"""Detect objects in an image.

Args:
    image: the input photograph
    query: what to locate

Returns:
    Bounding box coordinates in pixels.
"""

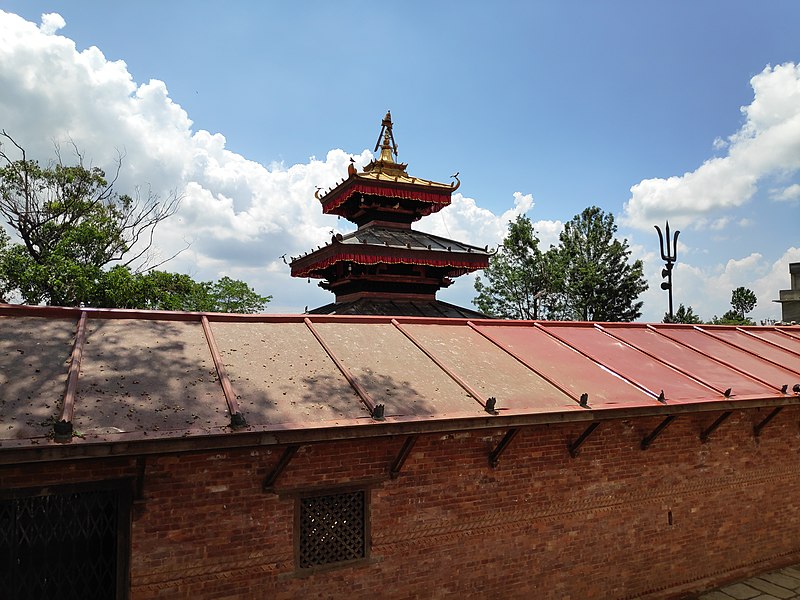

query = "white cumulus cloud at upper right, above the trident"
[622,63,800,229]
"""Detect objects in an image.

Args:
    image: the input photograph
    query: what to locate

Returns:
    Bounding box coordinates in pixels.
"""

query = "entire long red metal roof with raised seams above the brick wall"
[0,305,800,460]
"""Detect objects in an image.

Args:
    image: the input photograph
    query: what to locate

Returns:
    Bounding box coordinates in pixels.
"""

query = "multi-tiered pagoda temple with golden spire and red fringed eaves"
[291,112,491,318]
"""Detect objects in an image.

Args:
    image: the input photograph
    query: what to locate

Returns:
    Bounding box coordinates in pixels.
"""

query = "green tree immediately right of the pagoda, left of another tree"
[474,215,557,319]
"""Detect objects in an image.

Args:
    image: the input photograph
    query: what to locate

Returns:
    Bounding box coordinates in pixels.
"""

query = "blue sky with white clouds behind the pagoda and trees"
[0,1,800,320]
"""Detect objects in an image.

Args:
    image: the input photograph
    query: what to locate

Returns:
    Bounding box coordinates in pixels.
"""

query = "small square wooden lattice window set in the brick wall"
[298,490,367,569]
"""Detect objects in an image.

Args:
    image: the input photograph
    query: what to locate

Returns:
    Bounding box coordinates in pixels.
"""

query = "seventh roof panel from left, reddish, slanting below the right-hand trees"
[545,325,718,401]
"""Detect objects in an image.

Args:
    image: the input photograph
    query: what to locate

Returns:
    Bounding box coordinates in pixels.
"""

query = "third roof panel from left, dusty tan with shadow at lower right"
[212,322,369,425]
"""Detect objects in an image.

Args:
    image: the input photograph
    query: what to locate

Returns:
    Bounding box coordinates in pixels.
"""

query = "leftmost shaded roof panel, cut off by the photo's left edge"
[0,317,77,440]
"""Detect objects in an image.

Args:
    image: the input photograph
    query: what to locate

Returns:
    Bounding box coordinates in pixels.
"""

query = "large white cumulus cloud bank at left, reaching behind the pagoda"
[0,11,524,312]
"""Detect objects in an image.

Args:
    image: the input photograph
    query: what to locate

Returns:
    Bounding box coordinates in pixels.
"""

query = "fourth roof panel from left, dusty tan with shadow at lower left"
[314,322,482,416]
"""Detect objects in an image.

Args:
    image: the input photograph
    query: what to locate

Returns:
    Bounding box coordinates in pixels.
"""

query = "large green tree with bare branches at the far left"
[0,131,180,306]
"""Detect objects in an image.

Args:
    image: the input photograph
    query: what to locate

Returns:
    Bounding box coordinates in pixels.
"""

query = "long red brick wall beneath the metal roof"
[0,408,800,599]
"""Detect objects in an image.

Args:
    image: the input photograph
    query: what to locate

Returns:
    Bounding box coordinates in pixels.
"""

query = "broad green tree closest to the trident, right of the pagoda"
[558,206,648,321]
